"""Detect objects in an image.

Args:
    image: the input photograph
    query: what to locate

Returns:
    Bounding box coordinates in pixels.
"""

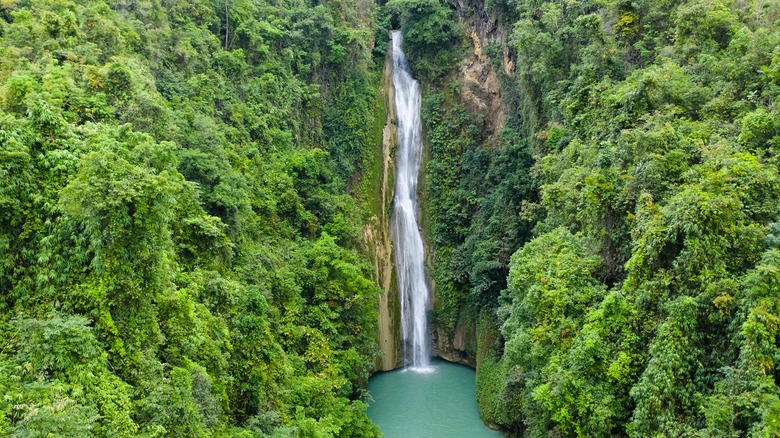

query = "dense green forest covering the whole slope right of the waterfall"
[402,0,780,437]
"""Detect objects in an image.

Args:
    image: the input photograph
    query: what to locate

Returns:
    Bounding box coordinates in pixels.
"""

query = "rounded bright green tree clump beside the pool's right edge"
[499,228,604,433]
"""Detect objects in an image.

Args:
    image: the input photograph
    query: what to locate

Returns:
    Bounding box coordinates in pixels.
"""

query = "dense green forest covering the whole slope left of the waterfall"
[0,0,378,437]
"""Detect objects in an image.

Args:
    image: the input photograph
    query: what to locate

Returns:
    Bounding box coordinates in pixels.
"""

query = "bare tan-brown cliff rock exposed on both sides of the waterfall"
[374,0,515,370]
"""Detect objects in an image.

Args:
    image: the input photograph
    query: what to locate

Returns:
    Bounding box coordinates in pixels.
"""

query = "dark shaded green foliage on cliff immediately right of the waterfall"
[423,91,534,323]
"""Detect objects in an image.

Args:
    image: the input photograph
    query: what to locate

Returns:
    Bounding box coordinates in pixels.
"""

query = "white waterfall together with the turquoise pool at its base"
[367,30,499,438]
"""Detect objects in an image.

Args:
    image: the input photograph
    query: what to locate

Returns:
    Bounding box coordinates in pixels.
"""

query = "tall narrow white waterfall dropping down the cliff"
[390,31,431,371]
